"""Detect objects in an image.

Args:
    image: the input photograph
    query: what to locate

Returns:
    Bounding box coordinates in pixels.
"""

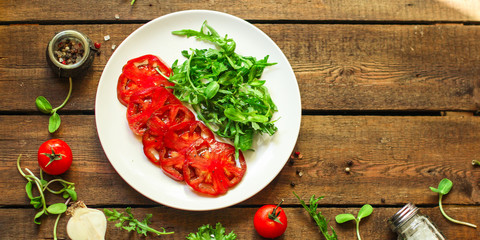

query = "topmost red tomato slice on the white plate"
[117,55,174,106]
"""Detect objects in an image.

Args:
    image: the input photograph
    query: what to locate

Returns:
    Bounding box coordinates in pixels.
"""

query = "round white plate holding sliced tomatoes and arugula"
[95,10,301,211]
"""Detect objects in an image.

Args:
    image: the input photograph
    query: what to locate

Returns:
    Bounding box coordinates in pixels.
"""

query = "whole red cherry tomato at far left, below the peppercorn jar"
[38,139,72,175]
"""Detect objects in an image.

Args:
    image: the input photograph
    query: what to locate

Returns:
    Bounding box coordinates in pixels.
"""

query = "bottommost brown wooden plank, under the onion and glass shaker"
[0,206,480,240]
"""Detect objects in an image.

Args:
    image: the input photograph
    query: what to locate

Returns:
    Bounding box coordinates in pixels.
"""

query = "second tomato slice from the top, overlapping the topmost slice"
[127,87,181,135]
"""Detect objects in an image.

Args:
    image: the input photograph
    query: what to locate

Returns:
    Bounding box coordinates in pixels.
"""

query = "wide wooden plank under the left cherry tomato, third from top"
[0,115,480,206]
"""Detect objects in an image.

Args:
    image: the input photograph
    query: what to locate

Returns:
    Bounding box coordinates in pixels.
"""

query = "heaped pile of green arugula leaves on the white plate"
[169,22,277,155]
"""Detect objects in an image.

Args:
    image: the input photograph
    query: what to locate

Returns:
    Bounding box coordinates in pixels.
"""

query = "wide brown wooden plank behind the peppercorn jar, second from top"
[0,24,480,111]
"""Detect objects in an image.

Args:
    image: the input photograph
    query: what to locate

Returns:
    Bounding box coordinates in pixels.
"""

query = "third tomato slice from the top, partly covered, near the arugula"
[147,104,195,132]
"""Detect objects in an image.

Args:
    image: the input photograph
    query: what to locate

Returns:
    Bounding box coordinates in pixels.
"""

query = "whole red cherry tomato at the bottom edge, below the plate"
[253,200,287,238]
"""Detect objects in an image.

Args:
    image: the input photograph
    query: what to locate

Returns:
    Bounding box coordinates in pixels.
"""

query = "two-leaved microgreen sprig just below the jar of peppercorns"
[35,77,73,133]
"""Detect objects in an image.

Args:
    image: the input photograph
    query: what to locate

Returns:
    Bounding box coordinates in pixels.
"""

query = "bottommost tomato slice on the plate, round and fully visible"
[183,140,247,196]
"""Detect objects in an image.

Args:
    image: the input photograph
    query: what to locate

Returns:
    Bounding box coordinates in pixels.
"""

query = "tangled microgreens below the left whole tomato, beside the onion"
[17,155,77,240]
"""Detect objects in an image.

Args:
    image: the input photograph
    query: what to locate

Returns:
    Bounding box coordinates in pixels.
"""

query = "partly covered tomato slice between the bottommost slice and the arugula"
[164,121,215,151]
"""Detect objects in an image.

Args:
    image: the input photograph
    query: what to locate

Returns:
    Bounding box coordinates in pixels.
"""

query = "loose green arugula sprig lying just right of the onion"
[103,207,174,236]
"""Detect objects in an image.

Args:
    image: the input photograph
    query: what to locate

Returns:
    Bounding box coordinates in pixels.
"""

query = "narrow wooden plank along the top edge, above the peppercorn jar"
[0,0,478,22]
